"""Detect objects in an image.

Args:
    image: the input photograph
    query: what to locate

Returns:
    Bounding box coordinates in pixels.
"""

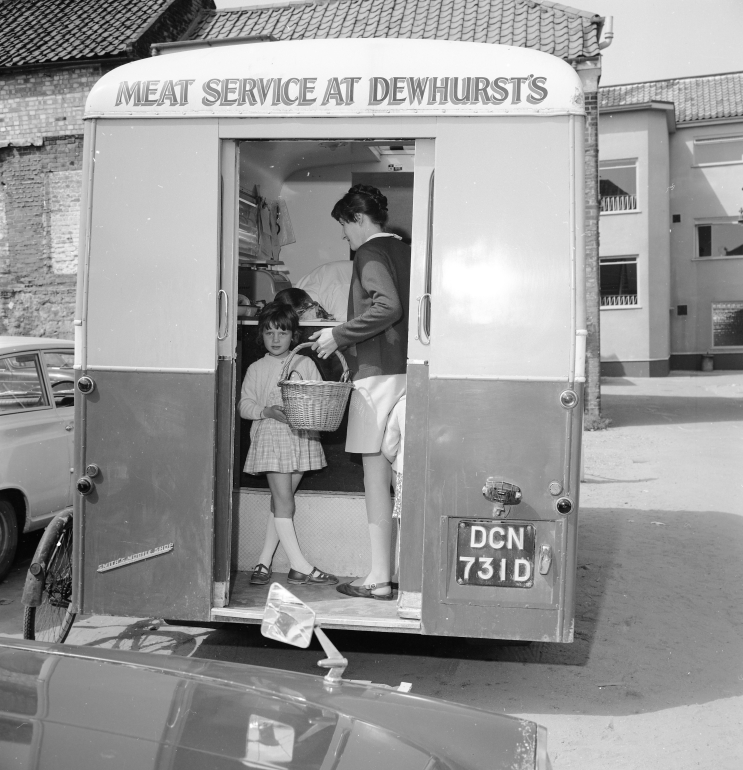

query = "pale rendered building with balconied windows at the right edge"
[599,72,743,377]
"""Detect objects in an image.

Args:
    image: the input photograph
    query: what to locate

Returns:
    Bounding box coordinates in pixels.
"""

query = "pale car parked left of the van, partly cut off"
[0,337,75,580]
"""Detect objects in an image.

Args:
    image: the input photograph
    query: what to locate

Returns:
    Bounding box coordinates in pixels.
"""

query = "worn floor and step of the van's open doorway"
[212,572,420,633]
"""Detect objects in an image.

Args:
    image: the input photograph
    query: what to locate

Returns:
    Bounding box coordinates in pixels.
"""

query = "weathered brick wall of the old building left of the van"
[0,0,214,339]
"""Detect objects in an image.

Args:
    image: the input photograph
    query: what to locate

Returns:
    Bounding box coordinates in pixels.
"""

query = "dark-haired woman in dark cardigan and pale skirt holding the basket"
[312,185,410,601]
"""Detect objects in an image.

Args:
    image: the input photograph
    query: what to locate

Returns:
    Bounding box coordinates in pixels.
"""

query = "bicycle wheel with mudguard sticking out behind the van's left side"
[23,515,75,642]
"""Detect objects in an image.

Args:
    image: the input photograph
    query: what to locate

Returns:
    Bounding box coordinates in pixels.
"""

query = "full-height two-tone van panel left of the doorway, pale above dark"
[81,120,226,620]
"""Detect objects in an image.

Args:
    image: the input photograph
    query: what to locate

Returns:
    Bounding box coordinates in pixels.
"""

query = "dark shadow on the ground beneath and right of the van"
[61,508,743,716]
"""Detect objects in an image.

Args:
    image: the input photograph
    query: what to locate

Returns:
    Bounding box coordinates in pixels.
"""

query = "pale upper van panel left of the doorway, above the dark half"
[85,120,219,371]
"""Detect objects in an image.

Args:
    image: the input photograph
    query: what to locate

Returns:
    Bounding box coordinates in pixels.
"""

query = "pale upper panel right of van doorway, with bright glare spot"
[430,117,574,378]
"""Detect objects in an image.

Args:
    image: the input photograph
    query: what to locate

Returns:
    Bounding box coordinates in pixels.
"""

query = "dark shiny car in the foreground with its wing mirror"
[0,584,551,770]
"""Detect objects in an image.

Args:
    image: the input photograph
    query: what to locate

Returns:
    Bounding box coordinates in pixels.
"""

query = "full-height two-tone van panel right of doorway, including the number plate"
[422,117,582,641]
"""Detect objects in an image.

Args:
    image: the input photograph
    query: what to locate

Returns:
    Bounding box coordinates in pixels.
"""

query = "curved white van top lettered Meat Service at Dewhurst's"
[85,38,584,118]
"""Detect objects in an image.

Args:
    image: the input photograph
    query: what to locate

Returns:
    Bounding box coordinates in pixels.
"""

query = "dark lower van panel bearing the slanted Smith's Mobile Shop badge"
[81,371,215,620]
